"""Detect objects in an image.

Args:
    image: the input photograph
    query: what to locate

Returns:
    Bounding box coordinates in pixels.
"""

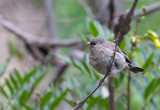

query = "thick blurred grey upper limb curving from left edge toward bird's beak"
[0,17,83,47]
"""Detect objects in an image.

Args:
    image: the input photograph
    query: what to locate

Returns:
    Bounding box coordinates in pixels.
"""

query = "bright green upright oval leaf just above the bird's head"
[89,21,99,37]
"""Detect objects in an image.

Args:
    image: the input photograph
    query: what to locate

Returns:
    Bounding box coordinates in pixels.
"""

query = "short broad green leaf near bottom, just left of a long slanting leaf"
[40,92,53,107]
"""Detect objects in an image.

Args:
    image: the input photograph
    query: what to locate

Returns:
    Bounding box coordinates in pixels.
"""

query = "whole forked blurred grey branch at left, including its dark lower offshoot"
[0,17,84,83]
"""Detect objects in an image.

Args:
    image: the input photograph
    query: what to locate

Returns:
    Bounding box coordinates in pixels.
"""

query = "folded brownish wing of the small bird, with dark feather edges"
[107,41,131,64]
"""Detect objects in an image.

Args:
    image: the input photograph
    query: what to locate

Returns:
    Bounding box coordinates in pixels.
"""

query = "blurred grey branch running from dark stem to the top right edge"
[134,2,160,17]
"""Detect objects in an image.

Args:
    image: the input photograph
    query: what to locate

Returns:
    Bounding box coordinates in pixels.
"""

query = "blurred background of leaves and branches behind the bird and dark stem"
[0,0,160,110]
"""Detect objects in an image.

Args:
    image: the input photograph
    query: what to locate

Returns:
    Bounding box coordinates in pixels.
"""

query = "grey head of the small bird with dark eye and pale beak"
[87,38,105,48]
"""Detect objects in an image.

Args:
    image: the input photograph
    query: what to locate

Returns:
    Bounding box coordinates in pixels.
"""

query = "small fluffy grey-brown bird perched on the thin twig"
[87,38,144,75]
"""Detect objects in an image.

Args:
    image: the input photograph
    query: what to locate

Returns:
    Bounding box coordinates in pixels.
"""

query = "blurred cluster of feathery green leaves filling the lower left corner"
[0,64,69,110]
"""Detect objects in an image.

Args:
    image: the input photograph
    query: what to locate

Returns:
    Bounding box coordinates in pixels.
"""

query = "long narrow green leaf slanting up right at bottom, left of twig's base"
[50,89,69,110]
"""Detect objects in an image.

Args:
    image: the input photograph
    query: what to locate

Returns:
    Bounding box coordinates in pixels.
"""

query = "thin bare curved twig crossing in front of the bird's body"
[72,33,119,110]
